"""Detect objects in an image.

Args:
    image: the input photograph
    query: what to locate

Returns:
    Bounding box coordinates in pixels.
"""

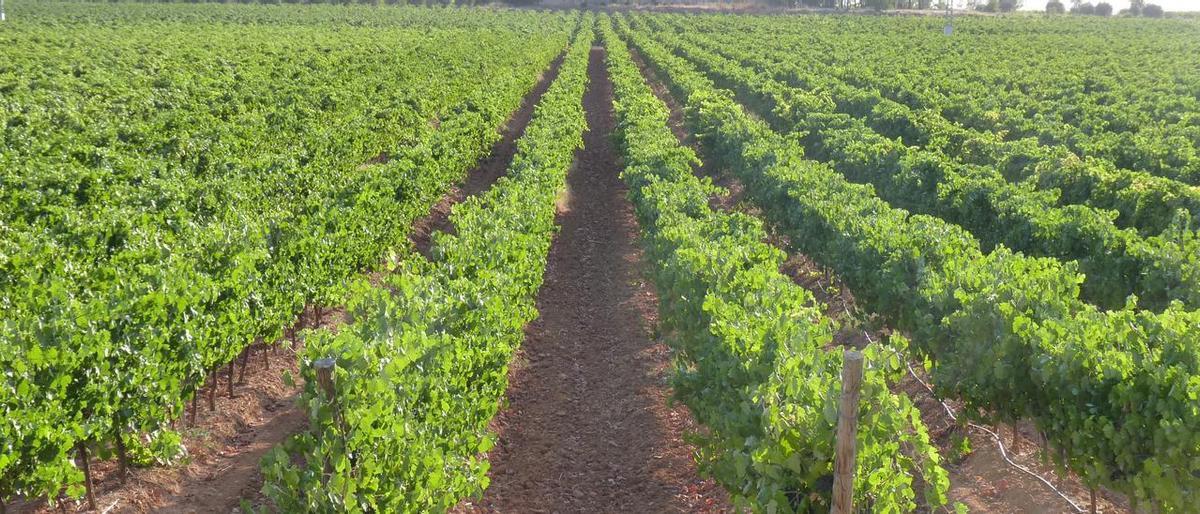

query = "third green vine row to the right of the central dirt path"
[638,16,1200,310]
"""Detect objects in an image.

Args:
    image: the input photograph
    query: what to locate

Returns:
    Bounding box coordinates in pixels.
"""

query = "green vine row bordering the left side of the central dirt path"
[263,19,594,513]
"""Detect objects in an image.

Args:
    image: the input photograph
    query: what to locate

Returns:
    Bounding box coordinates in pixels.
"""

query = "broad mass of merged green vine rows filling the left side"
[0,5,574,500]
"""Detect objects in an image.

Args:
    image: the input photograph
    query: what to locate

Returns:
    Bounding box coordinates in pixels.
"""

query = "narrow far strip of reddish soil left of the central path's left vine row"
[408,53,566,257]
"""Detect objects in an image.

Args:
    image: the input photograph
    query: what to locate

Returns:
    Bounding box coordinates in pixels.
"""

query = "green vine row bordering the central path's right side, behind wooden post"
[604,21,949,513]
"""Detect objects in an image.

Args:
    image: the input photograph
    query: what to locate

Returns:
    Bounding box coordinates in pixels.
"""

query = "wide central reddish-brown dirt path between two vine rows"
[458,48,730,513]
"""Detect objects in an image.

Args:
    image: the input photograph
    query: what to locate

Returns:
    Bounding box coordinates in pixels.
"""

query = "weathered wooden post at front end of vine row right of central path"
[829,349,863,514]
